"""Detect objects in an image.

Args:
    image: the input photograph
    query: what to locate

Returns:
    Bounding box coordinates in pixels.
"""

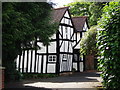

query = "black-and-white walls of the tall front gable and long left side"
[16,11,74,73]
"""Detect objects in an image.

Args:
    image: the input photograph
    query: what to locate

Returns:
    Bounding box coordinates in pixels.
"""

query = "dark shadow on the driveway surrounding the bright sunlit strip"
[4,72,99,90]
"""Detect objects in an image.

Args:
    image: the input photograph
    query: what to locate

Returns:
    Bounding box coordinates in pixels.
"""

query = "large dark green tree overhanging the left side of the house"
[2,2,57,79]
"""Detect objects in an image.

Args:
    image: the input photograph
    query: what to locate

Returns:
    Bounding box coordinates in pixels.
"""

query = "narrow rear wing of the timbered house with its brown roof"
[72,16,89,72]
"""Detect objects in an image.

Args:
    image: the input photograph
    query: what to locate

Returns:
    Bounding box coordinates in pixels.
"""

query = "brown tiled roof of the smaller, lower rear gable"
[72,16,89,31]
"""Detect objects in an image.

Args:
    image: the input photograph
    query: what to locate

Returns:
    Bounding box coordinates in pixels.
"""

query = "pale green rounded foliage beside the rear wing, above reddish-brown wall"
[80,26,97,55]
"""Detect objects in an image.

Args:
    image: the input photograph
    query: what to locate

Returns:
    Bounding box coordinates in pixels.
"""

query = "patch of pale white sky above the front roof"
[48,0,73,8]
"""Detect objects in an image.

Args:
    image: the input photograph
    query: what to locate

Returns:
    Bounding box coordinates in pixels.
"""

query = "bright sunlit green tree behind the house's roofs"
[67,2,106,26]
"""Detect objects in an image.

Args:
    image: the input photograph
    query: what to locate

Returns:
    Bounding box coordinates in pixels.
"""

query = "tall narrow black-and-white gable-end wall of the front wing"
[59,11,74,72]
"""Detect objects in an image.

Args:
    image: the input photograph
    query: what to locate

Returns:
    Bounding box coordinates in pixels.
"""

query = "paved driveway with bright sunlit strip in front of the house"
[6,72,101,90]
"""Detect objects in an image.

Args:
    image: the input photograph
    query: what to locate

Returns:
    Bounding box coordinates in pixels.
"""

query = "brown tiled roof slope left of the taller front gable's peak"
[52,7,69,22]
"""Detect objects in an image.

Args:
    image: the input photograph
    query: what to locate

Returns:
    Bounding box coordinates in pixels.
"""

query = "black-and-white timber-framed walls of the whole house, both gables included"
[16,7,88,74]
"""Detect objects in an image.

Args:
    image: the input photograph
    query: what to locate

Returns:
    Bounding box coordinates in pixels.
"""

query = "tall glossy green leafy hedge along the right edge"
[98,2,120,90]
